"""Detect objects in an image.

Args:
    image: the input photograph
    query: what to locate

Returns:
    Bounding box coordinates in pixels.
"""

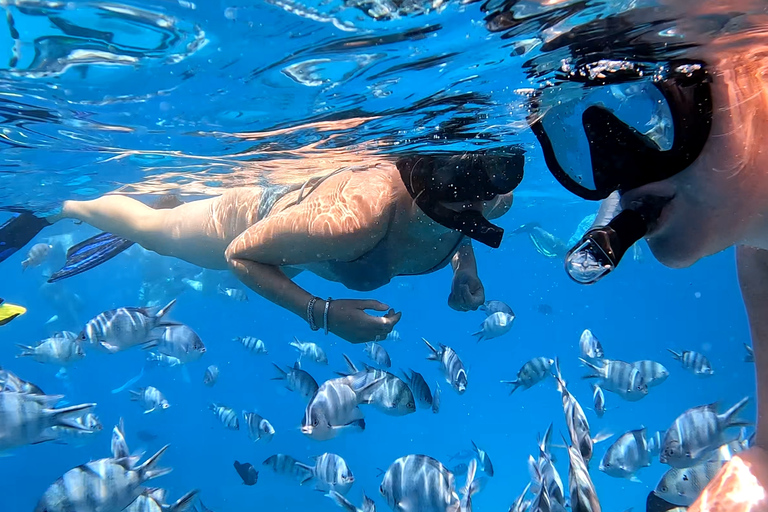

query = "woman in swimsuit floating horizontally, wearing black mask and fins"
[0,152,524,343]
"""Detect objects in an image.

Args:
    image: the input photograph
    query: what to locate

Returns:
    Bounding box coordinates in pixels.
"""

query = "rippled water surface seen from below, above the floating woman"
[0,0,764,210]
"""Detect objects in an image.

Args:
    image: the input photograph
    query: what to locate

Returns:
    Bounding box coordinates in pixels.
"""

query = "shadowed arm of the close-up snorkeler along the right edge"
[736,247,768,448]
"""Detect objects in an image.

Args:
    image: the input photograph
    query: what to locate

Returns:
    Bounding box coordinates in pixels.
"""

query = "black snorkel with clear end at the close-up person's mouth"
[565,210,651,284]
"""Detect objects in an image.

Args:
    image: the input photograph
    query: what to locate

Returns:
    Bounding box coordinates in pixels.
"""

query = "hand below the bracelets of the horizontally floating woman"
[328,299,402,343]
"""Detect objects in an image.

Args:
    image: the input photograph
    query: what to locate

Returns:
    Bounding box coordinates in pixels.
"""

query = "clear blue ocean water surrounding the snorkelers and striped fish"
[0,1,755,512]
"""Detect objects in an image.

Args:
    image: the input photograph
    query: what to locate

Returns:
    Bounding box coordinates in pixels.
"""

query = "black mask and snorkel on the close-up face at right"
[531,60,712,284]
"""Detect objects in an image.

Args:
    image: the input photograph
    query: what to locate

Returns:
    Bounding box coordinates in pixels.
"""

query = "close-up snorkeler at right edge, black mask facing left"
[532,7,768,512]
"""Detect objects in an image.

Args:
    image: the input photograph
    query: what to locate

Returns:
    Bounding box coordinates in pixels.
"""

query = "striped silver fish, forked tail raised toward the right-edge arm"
[659,397,749,468]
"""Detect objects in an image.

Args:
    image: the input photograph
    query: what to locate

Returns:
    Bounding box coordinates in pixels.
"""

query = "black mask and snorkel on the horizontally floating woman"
[397,148,525,248]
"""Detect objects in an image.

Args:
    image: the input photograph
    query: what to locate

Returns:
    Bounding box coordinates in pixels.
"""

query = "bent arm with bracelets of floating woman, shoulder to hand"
[226,174,400,343]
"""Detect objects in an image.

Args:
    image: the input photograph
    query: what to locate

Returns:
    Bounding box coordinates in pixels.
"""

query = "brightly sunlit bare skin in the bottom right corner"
[688,446,768,512]
